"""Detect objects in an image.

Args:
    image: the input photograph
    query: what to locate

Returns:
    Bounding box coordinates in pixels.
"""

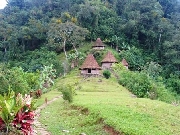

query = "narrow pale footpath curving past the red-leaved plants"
[33,95,62,135]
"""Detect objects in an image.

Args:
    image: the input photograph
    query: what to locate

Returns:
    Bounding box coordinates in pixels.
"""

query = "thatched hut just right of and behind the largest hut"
[101,51,118,69]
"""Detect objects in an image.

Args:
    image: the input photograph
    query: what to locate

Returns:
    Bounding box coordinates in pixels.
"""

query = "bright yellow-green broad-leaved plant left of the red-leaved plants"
[0,91,23,132]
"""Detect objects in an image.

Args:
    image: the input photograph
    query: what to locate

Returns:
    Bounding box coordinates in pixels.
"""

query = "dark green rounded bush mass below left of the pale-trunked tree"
[10,48,63,75]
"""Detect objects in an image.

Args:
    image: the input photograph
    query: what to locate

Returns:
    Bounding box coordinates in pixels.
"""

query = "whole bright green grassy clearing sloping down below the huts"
[36,71,180,135]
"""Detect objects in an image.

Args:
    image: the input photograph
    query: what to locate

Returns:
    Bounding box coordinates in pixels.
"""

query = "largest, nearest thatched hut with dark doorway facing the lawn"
[79,54,101,75]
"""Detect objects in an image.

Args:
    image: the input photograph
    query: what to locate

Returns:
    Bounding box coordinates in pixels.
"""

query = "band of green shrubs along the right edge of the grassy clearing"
[115,70,176,103]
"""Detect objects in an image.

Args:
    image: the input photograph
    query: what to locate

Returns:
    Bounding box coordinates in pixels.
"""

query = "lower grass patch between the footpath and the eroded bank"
[40,98,106,135]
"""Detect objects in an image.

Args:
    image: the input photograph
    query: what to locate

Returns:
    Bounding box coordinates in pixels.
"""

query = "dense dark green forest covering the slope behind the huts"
[0,0,180,94]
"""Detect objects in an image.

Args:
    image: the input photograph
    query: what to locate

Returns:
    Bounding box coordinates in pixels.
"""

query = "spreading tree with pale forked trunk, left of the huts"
[48,20,88,59]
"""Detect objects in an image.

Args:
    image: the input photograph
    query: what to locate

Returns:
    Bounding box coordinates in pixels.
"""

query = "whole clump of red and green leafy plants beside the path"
[0,89,35,134]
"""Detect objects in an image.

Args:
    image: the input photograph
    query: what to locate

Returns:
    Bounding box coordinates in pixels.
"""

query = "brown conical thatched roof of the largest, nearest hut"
[80,54,101,69]
